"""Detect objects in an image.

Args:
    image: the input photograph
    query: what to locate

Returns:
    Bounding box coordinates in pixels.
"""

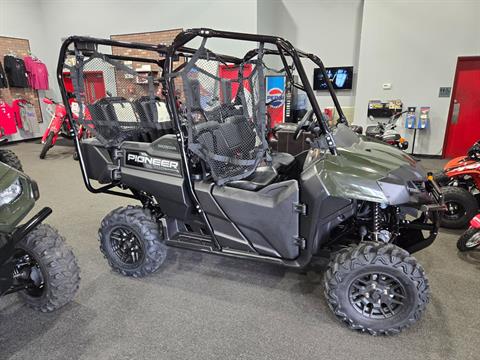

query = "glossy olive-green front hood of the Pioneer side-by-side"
[305,127,432,205]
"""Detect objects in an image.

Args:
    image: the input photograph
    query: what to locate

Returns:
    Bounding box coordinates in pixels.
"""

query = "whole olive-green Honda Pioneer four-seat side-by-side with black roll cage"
[57,29,443,334]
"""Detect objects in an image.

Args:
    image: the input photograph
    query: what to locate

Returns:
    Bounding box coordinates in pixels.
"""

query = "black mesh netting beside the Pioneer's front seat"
[176,41,268,185]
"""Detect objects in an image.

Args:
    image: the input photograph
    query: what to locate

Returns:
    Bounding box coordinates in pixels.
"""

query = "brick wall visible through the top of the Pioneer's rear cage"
[110,29,184,99]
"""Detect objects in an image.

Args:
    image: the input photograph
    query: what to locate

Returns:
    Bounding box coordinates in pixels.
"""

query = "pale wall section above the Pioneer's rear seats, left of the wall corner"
[41,0,257,98]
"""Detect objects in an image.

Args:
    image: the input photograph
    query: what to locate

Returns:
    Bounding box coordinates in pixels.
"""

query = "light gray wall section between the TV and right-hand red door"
[355,0,480,155]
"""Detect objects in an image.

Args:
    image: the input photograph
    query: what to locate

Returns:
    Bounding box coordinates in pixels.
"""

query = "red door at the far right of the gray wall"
[443,57,480,158]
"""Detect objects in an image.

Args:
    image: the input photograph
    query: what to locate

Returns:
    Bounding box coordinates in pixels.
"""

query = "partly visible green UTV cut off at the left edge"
[0,162,80,312]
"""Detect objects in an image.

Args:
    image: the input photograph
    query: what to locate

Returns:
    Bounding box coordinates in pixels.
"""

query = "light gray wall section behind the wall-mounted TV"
[257,0,363,107]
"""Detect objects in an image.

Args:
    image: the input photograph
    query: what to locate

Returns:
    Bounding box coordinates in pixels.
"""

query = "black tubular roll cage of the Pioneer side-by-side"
[57,28,347,203]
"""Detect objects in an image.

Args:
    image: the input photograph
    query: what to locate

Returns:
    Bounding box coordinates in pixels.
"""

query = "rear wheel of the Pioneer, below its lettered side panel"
[98,206,167,277]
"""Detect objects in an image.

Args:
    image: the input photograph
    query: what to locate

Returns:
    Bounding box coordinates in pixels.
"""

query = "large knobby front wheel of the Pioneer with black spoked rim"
[324,242,429,335]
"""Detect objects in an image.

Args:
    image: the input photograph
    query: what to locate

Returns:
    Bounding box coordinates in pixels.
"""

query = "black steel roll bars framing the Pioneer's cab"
[57,28,346,201]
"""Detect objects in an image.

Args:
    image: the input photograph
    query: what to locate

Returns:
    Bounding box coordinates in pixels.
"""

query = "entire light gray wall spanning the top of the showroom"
[0,0,480,154]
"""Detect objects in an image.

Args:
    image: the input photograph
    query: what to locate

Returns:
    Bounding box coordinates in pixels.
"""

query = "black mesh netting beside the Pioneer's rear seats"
[65,51,173,147]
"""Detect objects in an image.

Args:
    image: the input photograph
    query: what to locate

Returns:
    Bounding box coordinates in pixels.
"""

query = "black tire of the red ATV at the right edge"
[440,186,478,229]
